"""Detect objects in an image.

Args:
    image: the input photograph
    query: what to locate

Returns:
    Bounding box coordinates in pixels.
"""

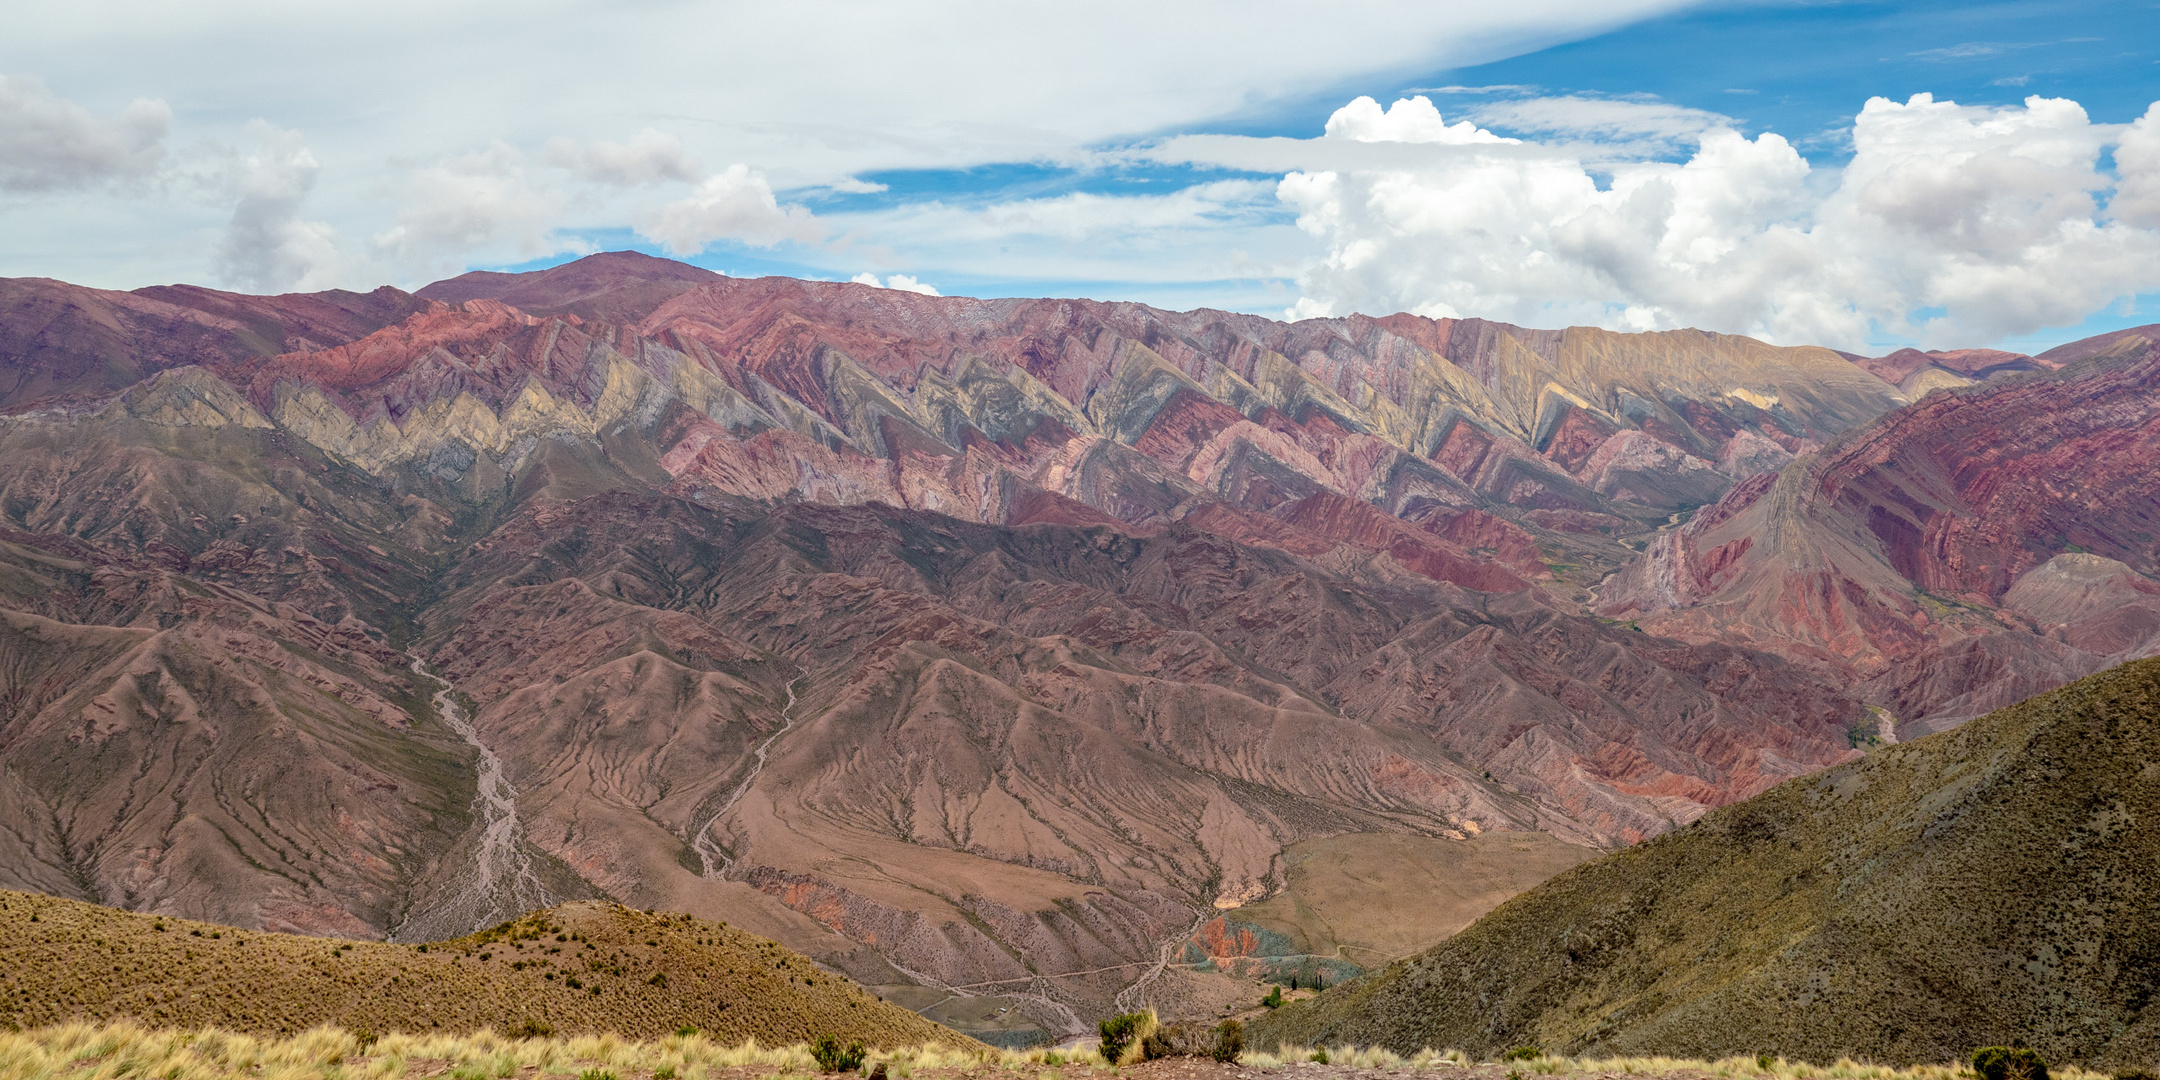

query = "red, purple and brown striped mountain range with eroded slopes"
[0,253,2160,1032]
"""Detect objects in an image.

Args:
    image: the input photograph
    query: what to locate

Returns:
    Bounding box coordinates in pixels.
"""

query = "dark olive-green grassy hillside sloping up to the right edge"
[1248,659,2160,1067]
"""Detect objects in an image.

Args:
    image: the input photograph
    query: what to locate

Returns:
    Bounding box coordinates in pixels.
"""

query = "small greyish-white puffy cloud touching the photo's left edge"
[0,76,173,192]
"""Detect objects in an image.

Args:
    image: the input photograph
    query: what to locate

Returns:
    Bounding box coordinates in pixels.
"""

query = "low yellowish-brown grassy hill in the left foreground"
[0,890,974,1045]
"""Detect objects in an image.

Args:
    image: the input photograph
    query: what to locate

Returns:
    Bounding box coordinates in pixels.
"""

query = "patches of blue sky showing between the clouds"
[494,0,2160,350]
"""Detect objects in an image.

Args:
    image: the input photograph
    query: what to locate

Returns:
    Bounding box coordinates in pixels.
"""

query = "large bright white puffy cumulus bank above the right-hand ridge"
[1268,95,2160,348]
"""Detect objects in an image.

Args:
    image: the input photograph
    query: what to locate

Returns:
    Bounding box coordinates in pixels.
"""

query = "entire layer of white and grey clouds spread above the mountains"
[0,0,2160,350]
